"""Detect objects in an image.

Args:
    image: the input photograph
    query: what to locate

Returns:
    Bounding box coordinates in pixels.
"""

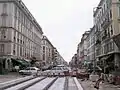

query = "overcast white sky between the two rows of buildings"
[22,0,100,62]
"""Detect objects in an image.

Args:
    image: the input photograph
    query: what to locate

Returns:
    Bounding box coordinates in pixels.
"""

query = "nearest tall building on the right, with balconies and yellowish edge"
[94,0,120,71]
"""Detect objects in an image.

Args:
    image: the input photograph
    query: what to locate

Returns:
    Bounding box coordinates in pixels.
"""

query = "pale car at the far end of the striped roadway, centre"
[43,66,69,76]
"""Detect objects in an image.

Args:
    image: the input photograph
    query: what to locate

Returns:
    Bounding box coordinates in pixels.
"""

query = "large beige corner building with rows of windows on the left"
[0,0,43,70]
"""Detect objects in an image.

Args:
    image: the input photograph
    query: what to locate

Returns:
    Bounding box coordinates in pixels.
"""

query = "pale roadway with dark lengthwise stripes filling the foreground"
[0,76,83,90]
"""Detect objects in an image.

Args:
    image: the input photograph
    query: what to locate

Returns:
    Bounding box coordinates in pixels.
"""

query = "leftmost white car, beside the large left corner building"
[19,67,39,75]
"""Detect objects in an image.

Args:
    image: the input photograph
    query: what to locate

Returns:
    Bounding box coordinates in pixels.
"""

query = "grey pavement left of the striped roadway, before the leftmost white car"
[0,72,23,83]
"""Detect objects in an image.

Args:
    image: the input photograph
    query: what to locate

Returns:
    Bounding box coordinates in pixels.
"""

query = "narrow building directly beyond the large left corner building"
[42,36,54,66]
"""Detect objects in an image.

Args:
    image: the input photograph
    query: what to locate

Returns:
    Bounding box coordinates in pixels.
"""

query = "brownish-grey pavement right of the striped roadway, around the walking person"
[79,79,120,90]
